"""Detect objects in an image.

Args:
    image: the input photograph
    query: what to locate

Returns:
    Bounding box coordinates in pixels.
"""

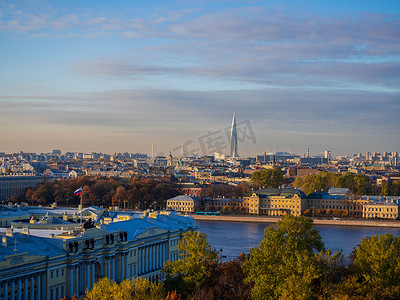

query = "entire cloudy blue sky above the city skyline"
[0,0,400,155]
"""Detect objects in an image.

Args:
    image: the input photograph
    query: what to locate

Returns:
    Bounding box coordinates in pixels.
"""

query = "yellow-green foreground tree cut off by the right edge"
[353,233,400,299]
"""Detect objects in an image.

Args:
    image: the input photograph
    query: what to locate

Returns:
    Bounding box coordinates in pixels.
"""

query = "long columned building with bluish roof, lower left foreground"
[0,212,196,300]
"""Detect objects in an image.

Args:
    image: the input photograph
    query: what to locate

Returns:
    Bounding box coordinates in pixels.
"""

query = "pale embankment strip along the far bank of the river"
[190,215,400,228]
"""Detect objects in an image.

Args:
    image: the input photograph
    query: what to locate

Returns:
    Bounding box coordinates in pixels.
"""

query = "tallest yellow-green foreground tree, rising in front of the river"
[243,215,324,299]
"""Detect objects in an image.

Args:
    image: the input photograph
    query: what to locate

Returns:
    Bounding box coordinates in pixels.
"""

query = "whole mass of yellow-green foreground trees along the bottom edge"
[86,219,400,300]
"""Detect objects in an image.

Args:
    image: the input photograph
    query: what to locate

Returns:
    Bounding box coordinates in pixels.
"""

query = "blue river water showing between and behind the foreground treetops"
[196,220,400,260]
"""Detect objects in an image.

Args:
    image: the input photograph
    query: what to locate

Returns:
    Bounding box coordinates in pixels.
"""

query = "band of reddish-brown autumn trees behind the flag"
[15,176,178,209]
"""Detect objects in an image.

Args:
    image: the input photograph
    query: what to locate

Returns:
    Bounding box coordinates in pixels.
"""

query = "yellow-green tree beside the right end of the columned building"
[163,231,218,293]
